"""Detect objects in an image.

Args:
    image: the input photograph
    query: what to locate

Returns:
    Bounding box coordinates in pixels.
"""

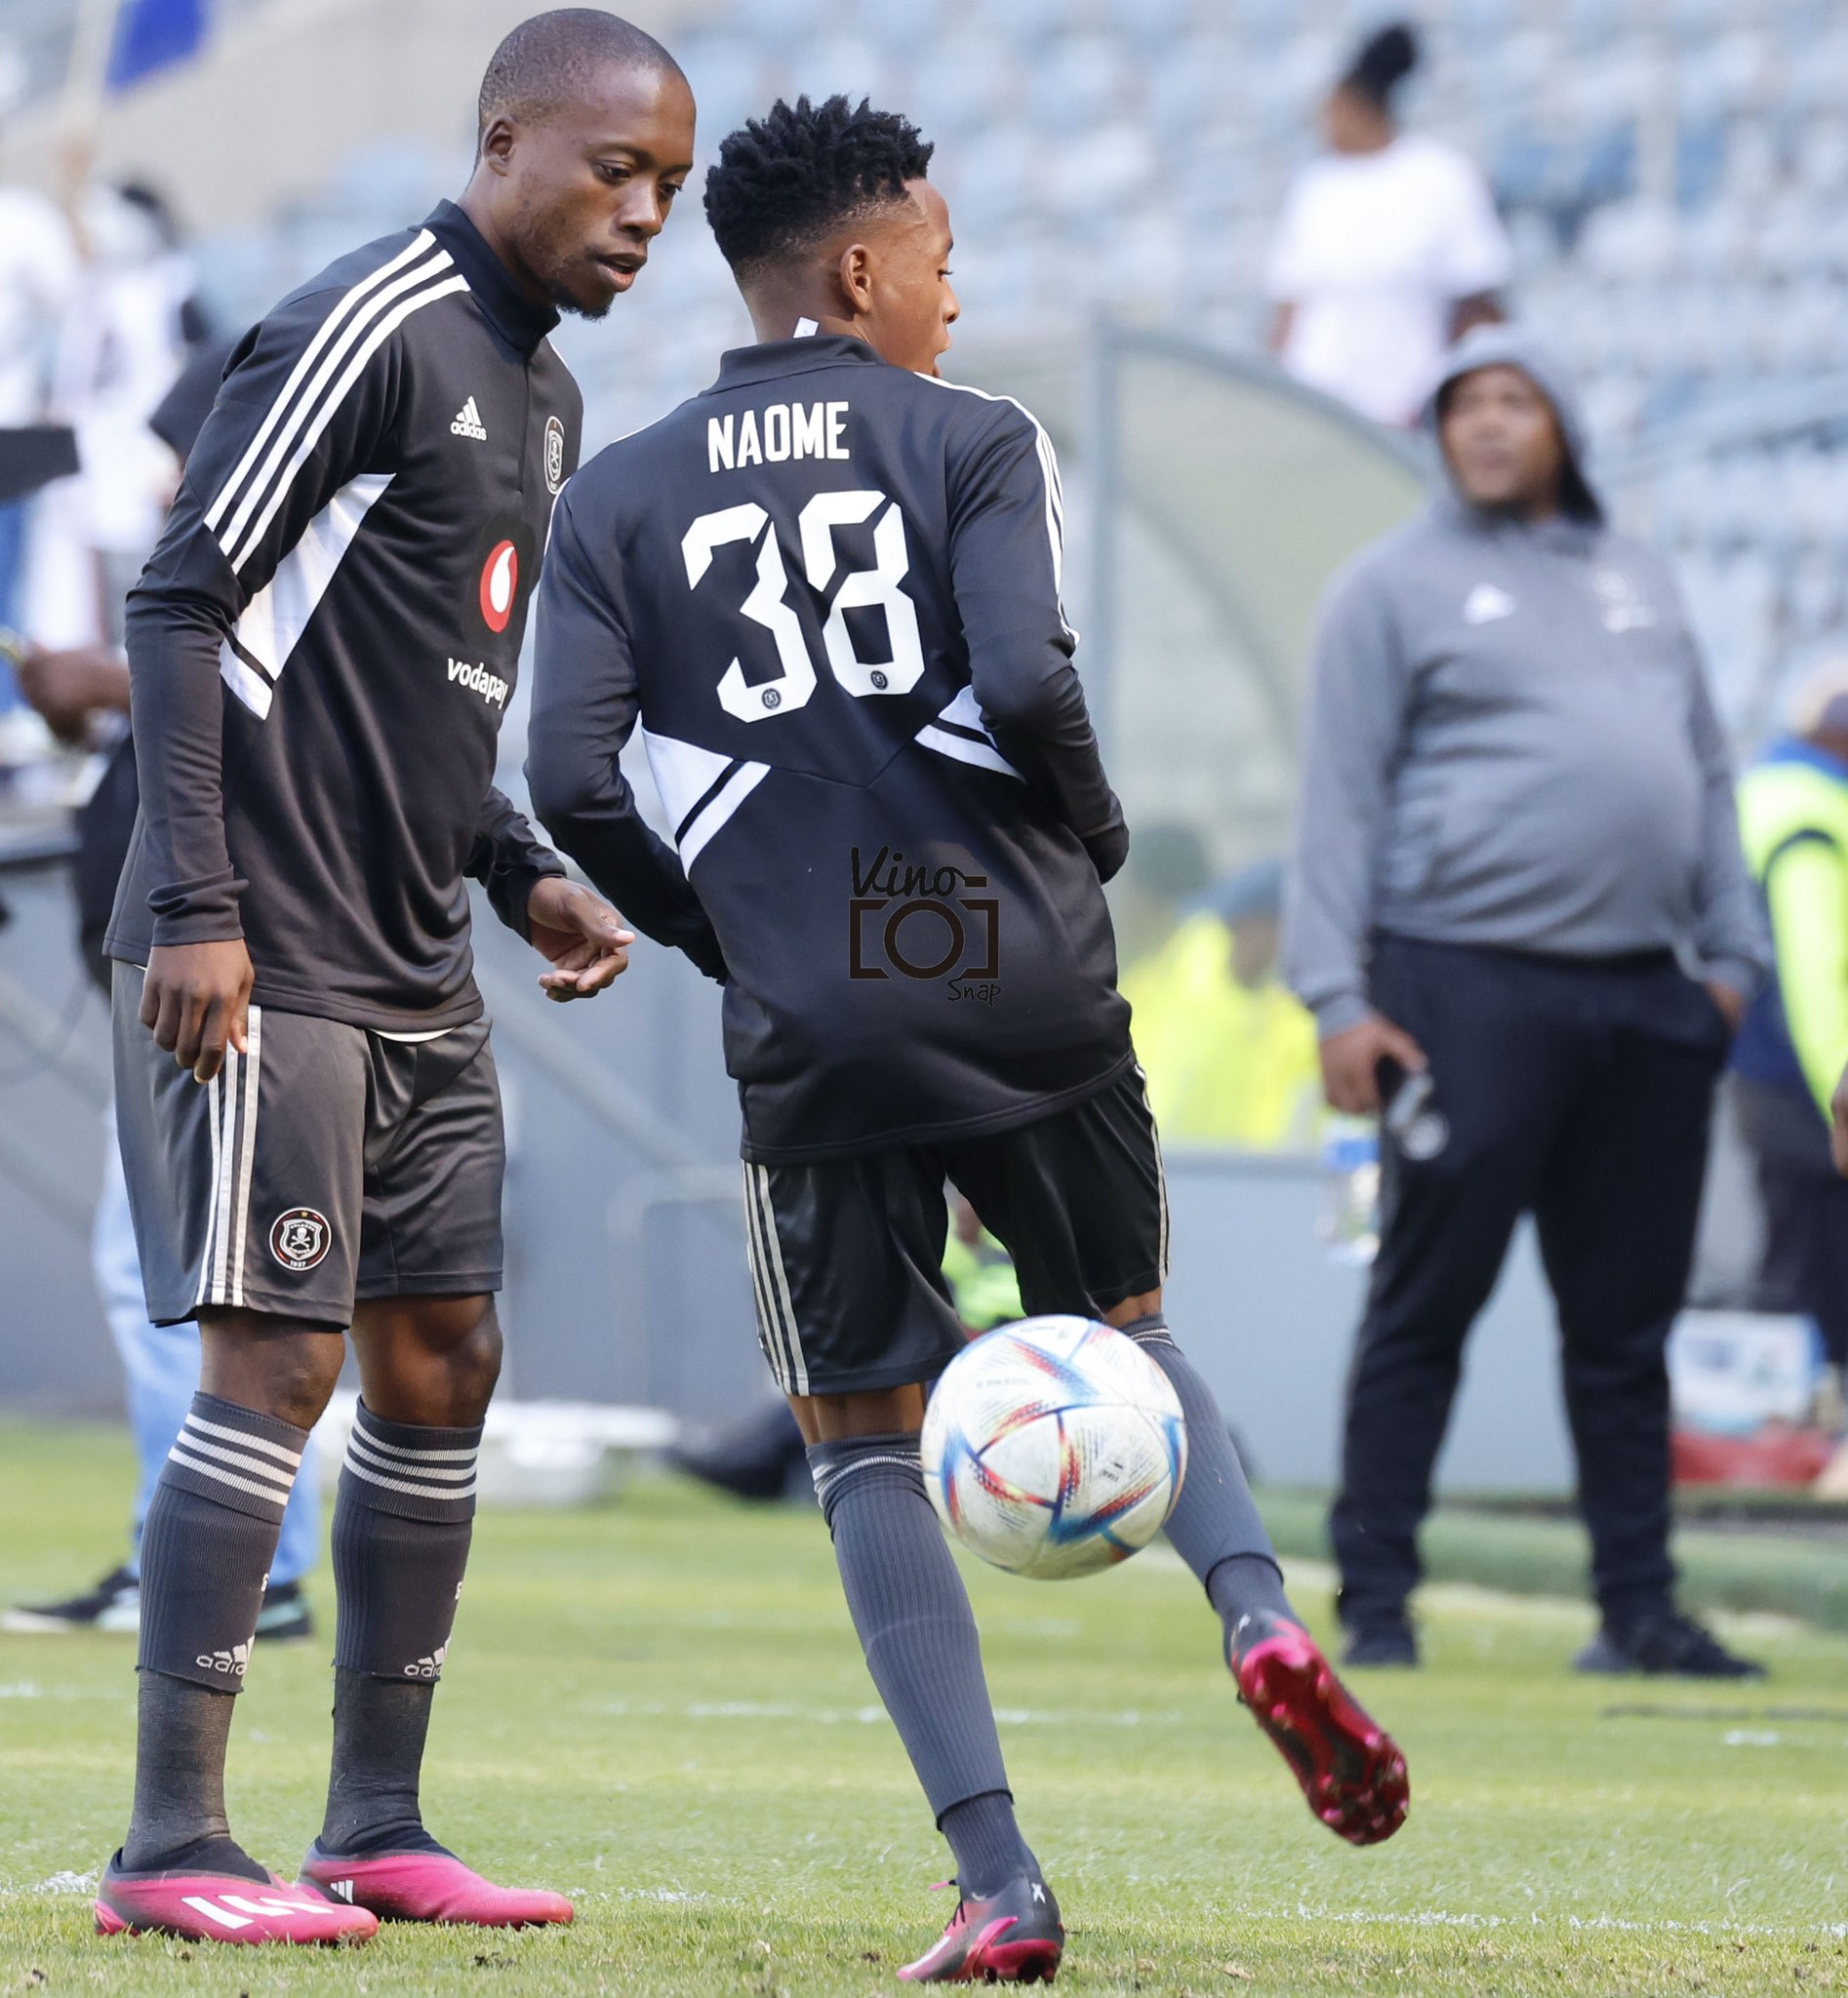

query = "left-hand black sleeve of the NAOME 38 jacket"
[526,486,725,981]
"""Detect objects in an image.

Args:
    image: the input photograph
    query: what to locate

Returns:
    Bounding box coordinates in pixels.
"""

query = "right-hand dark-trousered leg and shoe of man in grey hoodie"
[1537,965,1762,1678]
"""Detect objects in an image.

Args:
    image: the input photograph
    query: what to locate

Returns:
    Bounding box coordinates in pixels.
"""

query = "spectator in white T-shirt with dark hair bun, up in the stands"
[1265,24,1512,425]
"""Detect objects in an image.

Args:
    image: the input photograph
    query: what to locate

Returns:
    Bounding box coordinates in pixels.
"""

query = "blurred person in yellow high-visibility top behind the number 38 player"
[1121,861,1320,1151]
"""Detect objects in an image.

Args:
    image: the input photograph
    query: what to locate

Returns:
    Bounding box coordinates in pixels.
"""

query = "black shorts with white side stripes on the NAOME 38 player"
[745,1069,1169,1395]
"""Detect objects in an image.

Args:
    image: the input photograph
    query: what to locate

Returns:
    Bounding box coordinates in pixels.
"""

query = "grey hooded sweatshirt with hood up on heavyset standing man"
[1285,326,1768,1037]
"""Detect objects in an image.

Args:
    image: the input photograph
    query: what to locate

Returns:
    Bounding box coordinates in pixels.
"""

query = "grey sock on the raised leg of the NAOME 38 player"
[1123,1315,1297,1655]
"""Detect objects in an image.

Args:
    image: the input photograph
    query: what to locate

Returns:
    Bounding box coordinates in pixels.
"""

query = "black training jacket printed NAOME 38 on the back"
[528,336,1131,1161]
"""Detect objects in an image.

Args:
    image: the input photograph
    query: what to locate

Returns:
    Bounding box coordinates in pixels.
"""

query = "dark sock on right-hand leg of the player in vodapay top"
[320,1403,481,1858]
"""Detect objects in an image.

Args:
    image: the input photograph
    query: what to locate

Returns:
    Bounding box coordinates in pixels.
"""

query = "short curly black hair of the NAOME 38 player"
[705,96,935,278]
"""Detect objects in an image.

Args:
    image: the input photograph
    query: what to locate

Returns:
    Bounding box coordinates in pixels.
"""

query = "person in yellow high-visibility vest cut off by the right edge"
[1732,658,1848,1369]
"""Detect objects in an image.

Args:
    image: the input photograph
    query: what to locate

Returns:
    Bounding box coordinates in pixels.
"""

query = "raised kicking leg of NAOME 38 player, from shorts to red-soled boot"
[949,1071,1404,1844]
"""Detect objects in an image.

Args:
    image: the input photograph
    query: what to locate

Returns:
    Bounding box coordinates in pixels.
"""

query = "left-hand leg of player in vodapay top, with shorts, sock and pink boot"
[96,967,376,1942]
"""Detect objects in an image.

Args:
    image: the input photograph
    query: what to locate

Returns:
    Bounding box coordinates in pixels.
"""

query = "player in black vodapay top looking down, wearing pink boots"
[96,8,694,1942]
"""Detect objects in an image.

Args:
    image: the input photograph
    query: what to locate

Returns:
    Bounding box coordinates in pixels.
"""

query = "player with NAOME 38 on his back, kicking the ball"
[528,98,1404,1980]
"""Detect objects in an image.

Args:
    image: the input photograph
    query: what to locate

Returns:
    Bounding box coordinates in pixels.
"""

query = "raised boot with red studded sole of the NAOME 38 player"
[1230,1615,1411,1846]
